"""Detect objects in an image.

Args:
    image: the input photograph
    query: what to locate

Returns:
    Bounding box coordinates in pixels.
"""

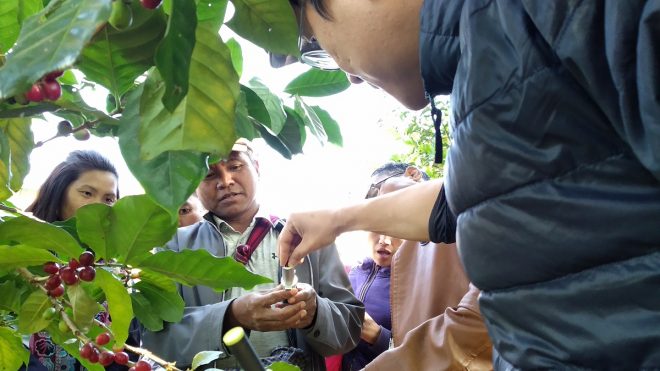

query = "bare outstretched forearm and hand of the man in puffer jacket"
[278,180,442,266]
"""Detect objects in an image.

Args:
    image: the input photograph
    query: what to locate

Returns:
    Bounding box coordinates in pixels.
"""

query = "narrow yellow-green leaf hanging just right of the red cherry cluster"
[94,268,133,344]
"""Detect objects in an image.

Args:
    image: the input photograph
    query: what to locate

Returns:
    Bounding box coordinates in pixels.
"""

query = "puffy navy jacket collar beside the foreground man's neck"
[419,0,465,96]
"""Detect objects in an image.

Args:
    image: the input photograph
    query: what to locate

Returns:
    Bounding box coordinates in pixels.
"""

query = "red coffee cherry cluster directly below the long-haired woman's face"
[43,251,96,298]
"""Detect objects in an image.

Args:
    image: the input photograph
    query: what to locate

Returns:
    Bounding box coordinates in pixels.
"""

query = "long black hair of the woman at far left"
[25,151,119,222]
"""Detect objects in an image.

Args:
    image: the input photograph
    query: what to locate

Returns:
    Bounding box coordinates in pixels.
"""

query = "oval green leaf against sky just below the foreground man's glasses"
[284,68,351,97]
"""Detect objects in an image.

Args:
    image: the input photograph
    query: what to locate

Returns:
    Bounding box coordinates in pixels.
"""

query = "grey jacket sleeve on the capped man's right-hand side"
[302,245,364,356]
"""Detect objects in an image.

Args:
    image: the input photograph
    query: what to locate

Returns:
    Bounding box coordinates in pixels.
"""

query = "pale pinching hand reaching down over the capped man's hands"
[277,210,339,267]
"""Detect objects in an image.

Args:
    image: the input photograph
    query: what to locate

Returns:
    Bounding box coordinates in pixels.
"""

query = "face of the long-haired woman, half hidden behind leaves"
[60,170,117,220]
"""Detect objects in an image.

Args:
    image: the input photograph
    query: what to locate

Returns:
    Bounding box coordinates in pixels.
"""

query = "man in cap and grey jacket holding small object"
[143,140,364,370]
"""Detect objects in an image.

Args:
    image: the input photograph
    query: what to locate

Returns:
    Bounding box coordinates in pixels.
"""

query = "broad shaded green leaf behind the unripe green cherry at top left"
[77,1,167,97]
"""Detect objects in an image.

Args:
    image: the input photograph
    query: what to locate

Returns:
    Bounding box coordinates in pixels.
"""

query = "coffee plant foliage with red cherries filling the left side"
[0,0,348,370]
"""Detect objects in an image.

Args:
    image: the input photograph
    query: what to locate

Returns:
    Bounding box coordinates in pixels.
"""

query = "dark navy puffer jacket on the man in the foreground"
[421,0,660,370]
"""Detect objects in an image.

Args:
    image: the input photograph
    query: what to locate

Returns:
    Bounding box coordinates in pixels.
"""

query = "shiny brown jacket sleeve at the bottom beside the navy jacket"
[365,285,492,371]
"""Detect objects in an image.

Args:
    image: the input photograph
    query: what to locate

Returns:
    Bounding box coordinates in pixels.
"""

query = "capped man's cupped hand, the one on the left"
[225,285,306,331]
